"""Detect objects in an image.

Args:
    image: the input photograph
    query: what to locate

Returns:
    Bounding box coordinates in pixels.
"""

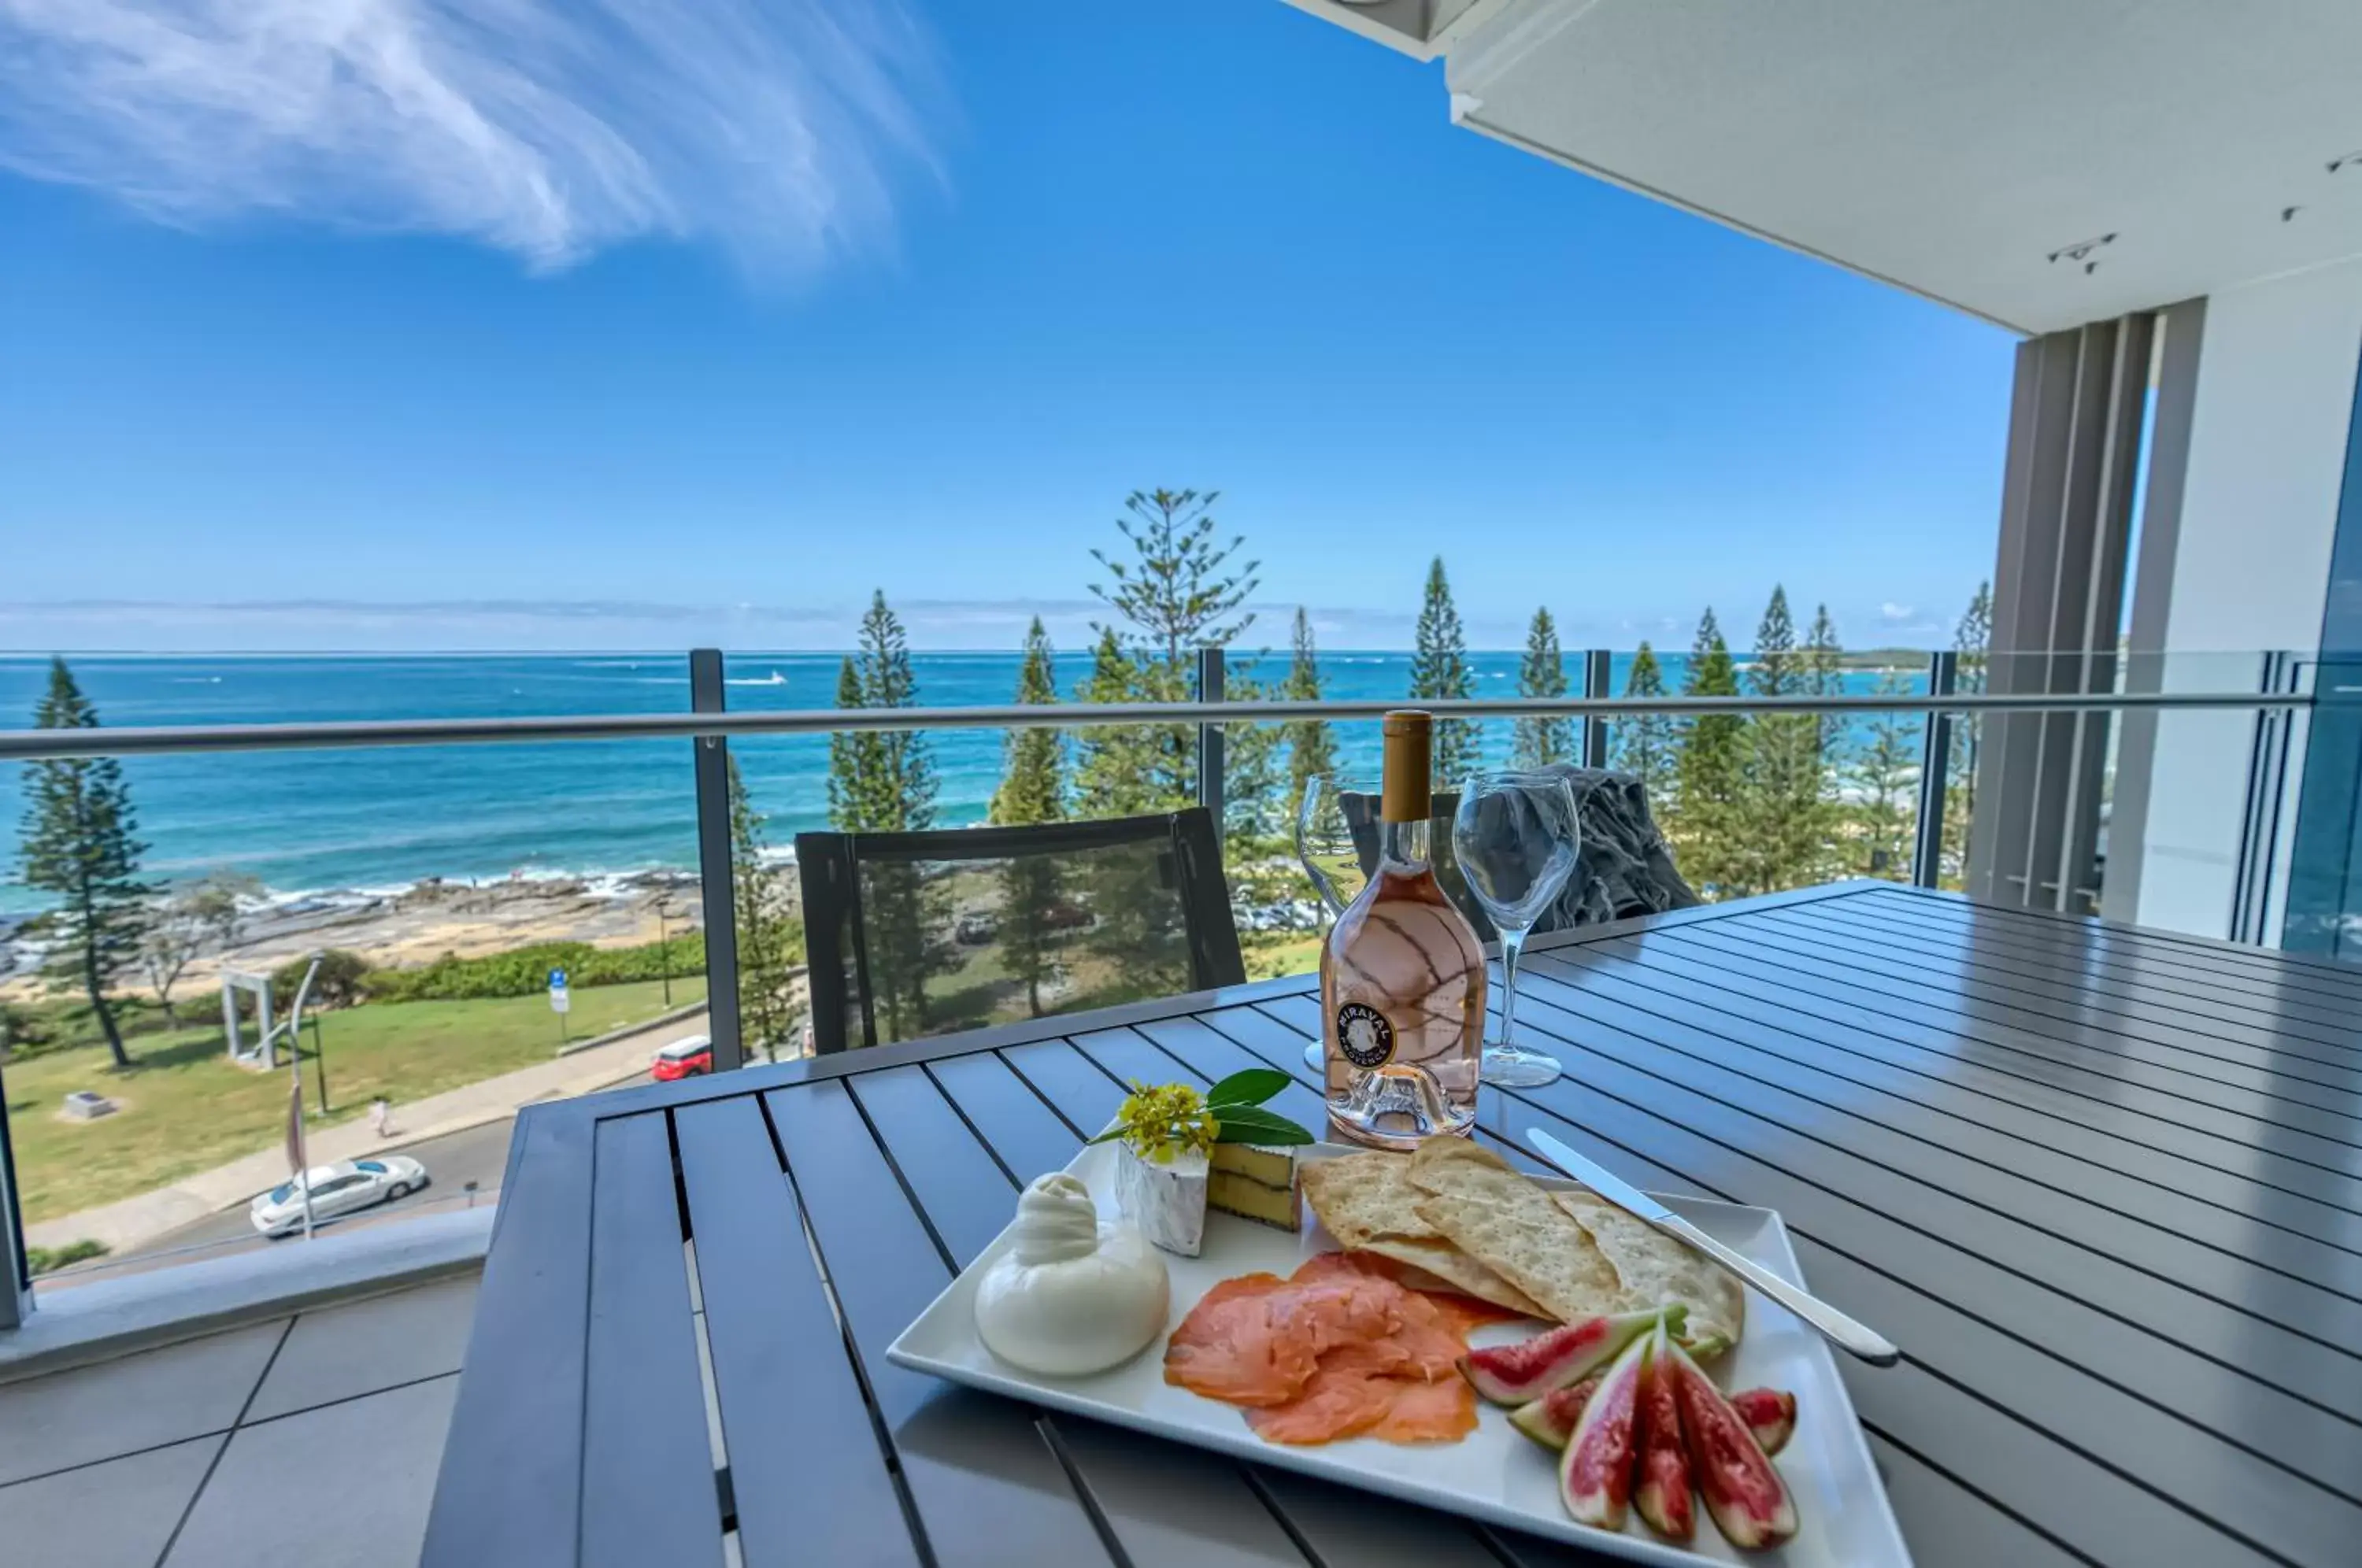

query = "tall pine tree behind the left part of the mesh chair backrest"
[829,593,952,1039]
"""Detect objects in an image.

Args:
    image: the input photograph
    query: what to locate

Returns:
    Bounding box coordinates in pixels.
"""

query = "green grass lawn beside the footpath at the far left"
[5,975,706,1221]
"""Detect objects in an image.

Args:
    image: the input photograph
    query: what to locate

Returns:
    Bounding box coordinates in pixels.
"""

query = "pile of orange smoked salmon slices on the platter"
[1164,1252,1488,1443]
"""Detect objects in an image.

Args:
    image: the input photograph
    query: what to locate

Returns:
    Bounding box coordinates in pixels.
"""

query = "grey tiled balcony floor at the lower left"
[0,1275,477,1568]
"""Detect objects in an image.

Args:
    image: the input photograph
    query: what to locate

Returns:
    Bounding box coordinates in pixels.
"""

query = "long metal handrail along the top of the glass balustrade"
[0,692,2312,760]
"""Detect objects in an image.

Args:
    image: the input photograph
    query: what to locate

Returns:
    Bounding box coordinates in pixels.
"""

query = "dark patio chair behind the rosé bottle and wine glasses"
[1339,763,1701,942]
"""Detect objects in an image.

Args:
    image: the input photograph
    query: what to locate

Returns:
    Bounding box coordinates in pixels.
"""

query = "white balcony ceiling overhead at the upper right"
[1294,0,2362,331]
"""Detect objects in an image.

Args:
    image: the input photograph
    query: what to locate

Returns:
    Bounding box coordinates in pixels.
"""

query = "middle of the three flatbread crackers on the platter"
[1410,1138,1623,1322]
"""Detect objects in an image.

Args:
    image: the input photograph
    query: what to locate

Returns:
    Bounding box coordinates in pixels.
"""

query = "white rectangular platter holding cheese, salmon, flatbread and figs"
[886,1143,1911,1568]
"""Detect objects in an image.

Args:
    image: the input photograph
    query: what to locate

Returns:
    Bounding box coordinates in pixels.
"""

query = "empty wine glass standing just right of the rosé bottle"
[1453,772,1583,1089]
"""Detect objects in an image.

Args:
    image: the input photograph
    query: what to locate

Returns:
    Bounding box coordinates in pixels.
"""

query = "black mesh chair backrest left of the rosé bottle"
[796,808,1247,1051]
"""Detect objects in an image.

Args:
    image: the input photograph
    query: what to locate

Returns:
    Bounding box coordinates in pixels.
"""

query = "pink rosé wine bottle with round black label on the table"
[1320,711,1486,1148]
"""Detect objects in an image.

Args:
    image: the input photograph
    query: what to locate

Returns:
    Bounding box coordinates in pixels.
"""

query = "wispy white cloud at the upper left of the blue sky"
[0,0,940,272]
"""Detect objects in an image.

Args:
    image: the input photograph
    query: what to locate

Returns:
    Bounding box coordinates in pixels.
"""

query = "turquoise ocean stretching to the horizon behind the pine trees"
[0,652,1925,916]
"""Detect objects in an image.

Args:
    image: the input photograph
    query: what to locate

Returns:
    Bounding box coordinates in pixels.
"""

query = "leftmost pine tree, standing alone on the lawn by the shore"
[17,659,154,1070]
